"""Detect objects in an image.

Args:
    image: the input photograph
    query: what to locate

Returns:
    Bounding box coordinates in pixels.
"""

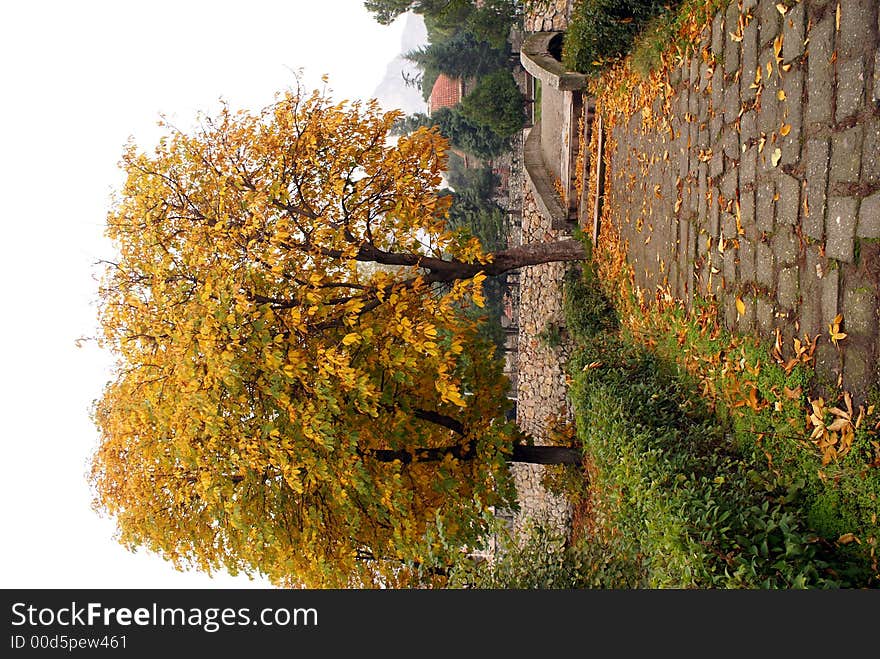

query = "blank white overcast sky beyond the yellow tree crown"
[0,0,422,588]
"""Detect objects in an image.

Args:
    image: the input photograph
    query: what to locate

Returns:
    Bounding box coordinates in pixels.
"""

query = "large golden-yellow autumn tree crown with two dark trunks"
[90,86,584,586]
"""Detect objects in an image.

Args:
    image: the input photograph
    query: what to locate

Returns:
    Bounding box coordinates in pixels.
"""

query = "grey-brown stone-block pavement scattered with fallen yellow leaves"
[603,0,880,399]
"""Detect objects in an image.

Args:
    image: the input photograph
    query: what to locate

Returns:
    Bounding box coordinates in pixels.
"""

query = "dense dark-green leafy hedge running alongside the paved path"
[571,334,843,588]
